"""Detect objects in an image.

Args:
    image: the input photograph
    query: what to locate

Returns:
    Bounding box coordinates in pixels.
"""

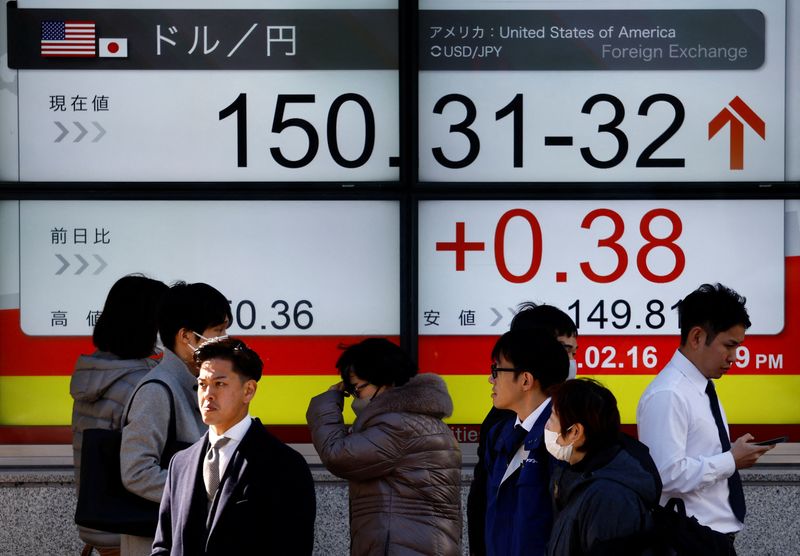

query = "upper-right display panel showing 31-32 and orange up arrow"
[418,0,800,182]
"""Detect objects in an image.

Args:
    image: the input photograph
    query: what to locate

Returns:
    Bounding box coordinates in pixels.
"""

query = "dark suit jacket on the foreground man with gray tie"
[152,419,316,556]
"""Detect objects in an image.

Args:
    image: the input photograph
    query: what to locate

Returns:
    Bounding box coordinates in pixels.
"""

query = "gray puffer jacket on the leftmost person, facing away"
[69,351,157,546]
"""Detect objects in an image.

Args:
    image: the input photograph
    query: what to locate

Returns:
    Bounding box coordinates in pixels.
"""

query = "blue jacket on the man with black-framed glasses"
[484,404,556,556]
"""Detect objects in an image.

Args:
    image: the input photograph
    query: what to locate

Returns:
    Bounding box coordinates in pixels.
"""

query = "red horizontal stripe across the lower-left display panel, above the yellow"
[0,309,400,376]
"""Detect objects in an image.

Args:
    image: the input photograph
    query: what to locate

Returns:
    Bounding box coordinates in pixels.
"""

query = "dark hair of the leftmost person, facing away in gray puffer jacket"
[92,274,168,359]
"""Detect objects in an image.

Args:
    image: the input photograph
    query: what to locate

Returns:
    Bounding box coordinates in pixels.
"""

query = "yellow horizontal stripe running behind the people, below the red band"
[0,375,800,426]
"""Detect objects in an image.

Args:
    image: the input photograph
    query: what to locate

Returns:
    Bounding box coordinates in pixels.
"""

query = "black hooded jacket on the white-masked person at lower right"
[548,445,661,556]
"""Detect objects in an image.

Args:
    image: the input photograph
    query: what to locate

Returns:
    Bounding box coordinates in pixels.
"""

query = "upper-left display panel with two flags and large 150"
[0,0,400,183]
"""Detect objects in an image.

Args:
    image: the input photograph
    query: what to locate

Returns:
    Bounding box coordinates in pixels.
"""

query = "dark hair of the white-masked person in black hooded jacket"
[551,378,620,453]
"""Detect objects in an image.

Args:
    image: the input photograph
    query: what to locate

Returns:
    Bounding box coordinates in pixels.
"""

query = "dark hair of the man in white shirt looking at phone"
[678,284,750,345]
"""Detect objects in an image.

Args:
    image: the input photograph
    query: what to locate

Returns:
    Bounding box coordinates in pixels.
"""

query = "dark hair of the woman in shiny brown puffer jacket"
[336,338,418,387]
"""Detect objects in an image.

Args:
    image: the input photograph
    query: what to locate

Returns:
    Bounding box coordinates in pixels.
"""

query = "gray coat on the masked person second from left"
[120,348,208,502]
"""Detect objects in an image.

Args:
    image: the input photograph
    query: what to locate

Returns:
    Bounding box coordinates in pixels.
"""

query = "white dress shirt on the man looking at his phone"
[636,351,742,533]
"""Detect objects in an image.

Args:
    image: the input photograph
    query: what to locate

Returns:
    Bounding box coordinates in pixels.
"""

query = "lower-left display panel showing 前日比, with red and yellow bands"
[0,200,400,427]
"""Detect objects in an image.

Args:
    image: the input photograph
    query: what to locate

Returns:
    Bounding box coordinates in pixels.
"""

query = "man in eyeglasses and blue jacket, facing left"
[483,330,569,556]
